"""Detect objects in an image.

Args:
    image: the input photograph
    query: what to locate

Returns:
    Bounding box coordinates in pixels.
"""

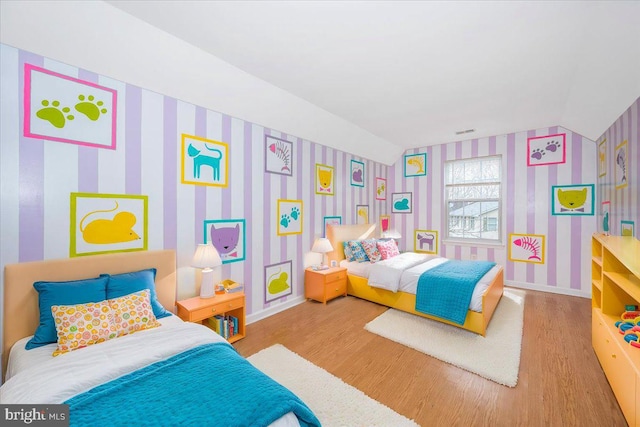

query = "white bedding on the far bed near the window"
[340,252,500,313]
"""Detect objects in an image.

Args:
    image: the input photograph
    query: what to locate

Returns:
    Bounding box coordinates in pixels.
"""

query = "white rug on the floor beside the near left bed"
[247,344,417,427]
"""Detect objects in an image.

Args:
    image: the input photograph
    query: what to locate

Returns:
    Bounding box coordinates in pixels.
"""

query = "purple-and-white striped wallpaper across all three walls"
[0,44,640,324]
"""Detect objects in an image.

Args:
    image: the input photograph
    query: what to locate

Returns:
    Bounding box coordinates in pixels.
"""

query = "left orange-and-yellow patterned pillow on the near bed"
[51,301,118,356]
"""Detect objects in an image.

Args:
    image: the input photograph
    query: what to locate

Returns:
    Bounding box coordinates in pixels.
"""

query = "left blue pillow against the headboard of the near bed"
[25,277,108,350]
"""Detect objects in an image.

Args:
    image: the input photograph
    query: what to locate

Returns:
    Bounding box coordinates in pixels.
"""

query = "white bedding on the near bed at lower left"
[0,316,300,427]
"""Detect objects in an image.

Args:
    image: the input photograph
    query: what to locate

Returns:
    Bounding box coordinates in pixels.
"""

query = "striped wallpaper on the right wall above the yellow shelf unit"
[597,98,640,239]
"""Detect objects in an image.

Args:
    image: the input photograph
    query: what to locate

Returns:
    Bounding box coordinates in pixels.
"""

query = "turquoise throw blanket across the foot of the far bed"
[416,260,496,325]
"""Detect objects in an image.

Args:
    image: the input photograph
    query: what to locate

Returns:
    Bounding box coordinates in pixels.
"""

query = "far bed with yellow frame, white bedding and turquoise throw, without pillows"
[327,224,504,336]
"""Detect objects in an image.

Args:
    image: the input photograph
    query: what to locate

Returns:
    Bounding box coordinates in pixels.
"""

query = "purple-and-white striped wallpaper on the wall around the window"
[389,127,596,296]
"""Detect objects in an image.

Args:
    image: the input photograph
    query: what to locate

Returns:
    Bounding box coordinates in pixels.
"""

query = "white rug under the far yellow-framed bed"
[365,289,525,387]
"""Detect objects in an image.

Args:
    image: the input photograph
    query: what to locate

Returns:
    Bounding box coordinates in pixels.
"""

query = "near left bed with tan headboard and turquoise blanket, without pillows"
[0,251,319,427]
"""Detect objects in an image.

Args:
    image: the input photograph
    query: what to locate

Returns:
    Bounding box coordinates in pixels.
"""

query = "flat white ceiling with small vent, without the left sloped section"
[108,0,640,148]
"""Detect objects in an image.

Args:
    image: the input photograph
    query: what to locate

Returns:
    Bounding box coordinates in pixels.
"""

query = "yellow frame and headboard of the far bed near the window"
[327,224,504,336]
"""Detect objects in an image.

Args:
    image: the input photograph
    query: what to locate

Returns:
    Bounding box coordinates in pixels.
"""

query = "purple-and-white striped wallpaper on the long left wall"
[0,44,388,316]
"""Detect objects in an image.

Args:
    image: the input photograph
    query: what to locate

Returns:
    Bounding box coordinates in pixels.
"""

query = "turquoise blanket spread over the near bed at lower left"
[64,343,320,427]
